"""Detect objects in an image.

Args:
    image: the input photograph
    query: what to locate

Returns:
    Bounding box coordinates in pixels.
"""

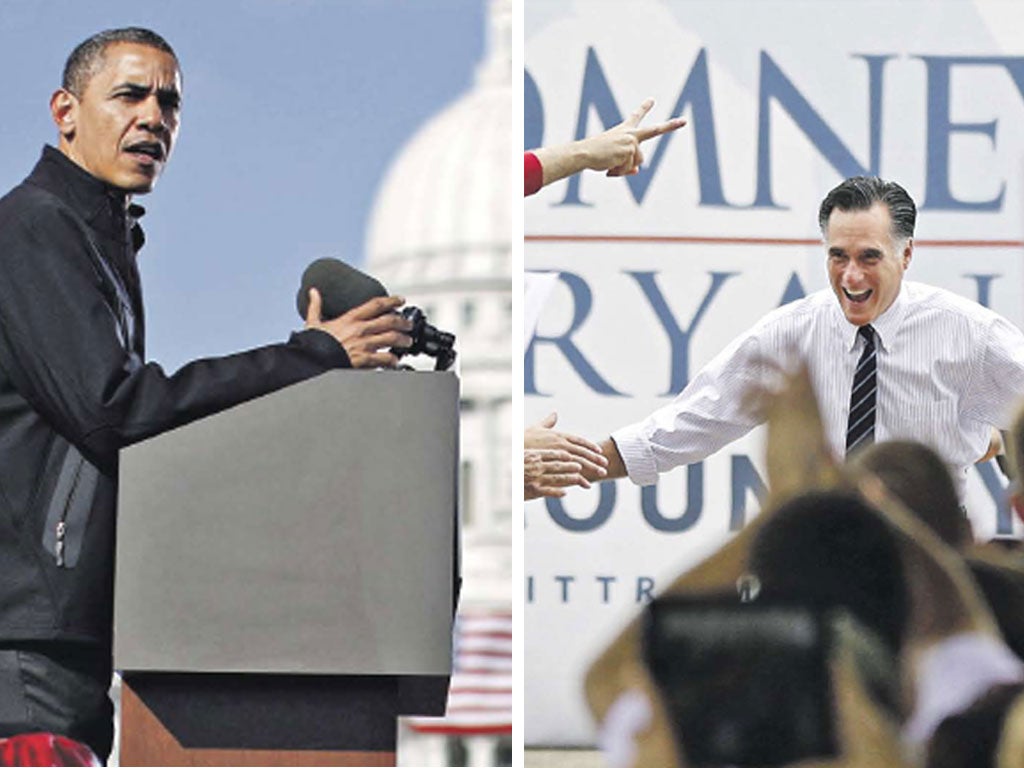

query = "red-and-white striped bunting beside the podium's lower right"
[406,611,512,736]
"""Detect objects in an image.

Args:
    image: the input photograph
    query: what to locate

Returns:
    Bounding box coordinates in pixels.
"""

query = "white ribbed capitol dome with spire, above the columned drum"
[367,0,512,292]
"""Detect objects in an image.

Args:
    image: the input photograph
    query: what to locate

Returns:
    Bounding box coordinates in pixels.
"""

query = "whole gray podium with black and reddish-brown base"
[114,371,459,766]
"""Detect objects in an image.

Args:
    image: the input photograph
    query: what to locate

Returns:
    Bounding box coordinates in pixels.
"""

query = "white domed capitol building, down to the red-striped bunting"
[367,0,522,569]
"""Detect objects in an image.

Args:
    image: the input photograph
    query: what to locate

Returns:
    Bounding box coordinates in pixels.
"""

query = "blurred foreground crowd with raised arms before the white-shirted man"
[587,368,1024,768]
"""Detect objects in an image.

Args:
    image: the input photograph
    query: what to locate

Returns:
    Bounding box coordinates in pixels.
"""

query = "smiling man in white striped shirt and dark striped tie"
[591,176,1024,505]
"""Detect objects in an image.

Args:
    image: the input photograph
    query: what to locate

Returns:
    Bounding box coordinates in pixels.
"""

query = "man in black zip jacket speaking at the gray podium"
[0,28,411,765]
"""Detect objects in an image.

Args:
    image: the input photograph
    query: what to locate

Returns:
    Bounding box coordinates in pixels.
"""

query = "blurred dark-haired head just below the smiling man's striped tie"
[851,440,971,550]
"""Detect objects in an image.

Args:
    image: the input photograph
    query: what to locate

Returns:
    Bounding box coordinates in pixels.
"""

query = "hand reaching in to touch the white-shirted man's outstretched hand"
[522,414,608,501]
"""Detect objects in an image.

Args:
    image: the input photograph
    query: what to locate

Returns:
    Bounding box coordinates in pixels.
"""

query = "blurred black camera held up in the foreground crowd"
[643,595,899,766]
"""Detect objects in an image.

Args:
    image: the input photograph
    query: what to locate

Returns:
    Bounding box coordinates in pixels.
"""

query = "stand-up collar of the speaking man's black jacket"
[28,144,145,250]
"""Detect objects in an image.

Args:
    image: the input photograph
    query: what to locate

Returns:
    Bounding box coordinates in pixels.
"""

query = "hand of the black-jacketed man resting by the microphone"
[306,288,413,368]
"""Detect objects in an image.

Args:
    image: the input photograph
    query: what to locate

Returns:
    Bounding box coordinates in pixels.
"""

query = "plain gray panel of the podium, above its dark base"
[114,371,459,675]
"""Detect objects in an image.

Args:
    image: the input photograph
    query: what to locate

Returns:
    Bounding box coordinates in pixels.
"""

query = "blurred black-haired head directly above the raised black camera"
[748,492,910,653]
